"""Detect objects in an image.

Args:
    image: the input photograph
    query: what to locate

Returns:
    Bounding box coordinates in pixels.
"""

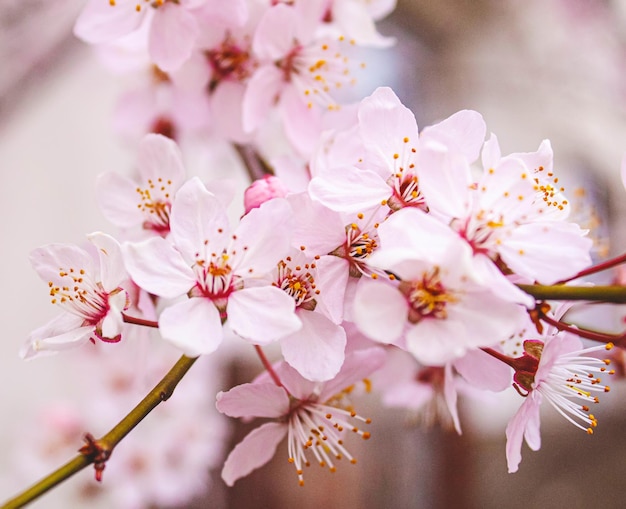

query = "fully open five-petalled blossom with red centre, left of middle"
[124,178,301,355]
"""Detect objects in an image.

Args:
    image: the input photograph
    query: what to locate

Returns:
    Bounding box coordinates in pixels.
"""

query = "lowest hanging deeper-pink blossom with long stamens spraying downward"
[216,348,385,486]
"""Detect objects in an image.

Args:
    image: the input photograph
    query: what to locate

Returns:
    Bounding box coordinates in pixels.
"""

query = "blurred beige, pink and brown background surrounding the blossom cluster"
[0,0,626,509]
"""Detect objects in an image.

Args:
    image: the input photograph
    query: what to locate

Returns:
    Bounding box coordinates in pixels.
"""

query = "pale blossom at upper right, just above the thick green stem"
[419,138,592,288]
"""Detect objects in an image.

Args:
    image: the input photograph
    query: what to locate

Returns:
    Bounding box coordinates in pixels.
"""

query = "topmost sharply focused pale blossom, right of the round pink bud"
[309,87,486,212]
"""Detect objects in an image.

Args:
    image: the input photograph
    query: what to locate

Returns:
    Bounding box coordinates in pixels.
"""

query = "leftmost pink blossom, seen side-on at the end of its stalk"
[20,232,130,359]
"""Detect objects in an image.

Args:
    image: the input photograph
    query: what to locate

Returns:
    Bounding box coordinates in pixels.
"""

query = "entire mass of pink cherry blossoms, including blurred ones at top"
[13,0,612,504]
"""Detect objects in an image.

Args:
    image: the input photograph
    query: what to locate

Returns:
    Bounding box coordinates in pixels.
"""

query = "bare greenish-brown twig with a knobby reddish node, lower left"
[0,355,197,509]
